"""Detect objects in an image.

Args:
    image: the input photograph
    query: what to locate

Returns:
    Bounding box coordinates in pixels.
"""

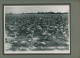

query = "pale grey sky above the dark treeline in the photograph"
[4,5,69,13]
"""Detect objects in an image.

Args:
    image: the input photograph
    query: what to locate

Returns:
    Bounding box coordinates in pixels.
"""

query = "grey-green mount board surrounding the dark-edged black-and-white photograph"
[0,0,80,58]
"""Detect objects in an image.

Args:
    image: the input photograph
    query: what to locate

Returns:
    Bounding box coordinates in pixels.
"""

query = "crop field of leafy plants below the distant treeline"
[4,13,70,51]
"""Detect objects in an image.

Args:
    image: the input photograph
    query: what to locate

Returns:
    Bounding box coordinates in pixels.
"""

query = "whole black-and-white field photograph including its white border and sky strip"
[3,5,70,54]
